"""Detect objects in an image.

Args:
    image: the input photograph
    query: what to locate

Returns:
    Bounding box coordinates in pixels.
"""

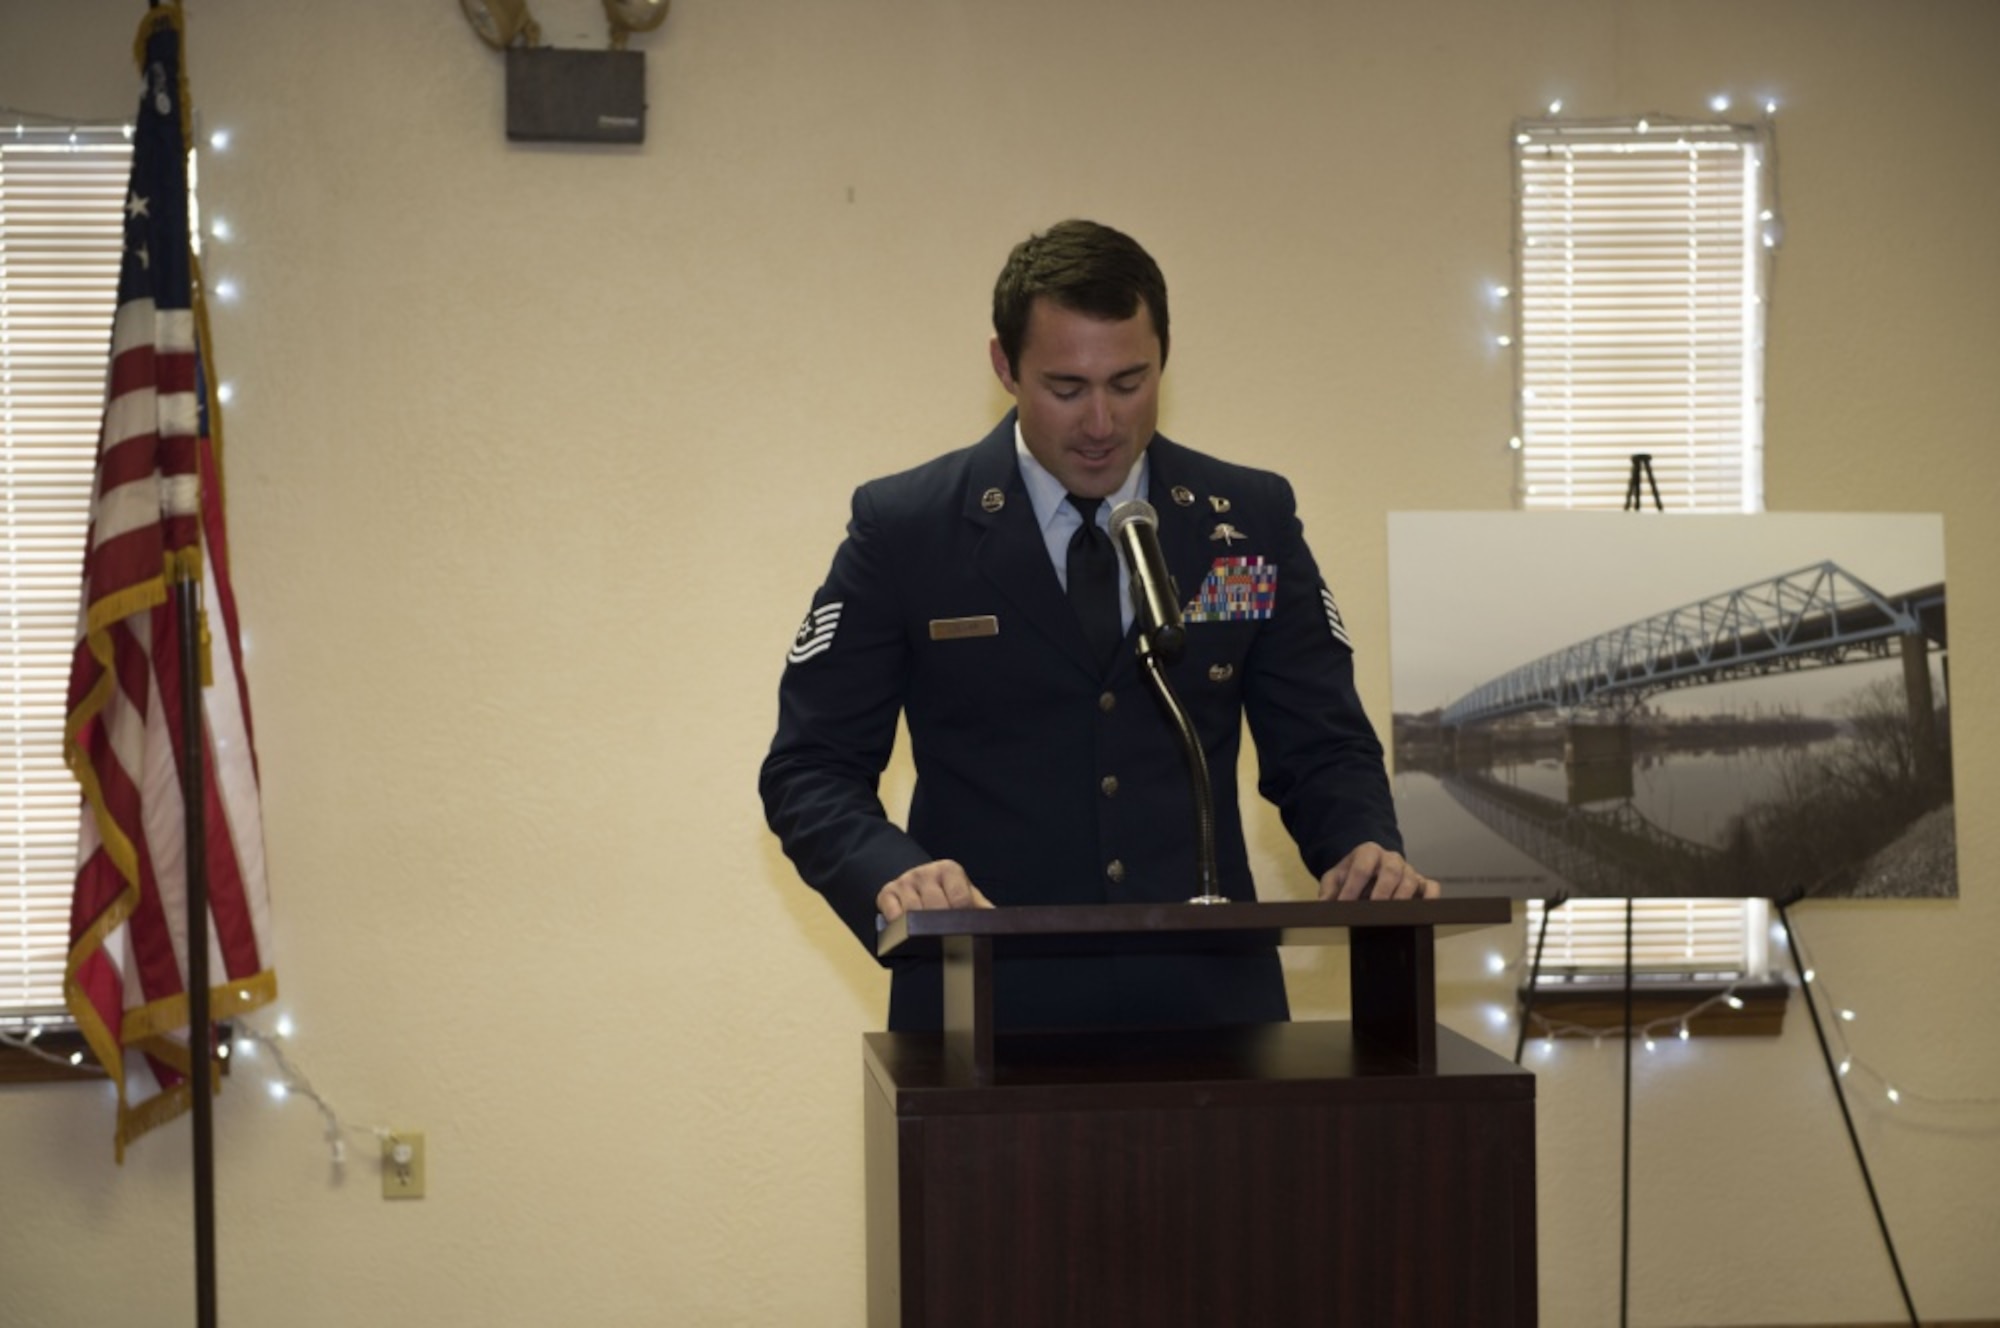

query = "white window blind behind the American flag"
[0,128,132,1026]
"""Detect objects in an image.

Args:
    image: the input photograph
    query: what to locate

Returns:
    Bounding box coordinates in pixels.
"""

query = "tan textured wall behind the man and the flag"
[0,0,2000,1328]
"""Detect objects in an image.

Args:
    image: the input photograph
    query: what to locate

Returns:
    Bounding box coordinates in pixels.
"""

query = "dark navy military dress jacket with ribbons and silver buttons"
[760,412,1402,1030]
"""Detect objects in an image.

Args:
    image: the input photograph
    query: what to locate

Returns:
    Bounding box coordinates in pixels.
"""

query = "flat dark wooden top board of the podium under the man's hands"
[876,898,1514,956]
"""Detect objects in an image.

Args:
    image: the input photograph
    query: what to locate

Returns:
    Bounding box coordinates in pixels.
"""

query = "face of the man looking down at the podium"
[992,298,1162,498]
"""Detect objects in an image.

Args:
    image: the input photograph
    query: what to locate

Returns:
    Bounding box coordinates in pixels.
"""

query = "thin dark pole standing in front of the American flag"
[174,566,216,1328]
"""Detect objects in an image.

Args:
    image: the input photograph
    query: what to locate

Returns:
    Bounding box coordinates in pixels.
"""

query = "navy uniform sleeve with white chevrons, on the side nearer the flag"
[758,488,930,954]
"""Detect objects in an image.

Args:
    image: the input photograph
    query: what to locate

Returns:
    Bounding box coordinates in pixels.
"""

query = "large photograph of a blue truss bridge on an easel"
[1388,512,1958,900]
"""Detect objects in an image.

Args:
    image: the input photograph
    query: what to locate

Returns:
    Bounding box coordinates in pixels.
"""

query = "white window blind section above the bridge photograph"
[1514,120,1766,512]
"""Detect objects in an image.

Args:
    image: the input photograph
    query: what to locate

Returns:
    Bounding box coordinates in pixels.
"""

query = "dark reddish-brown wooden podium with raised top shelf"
[864,900,1536,1328]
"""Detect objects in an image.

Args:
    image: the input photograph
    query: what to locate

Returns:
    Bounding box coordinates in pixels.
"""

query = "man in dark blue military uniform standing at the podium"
[758,220,1438,1030]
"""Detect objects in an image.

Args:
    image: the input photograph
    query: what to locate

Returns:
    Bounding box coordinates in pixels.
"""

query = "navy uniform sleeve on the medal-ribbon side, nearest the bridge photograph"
[1244,480,1402,878]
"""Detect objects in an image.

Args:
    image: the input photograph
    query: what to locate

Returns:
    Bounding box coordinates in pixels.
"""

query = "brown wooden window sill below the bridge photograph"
[1516,976,1792,1038]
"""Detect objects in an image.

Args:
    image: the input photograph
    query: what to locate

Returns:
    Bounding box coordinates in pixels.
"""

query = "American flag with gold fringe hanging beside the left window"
[64,4,278,1160]
